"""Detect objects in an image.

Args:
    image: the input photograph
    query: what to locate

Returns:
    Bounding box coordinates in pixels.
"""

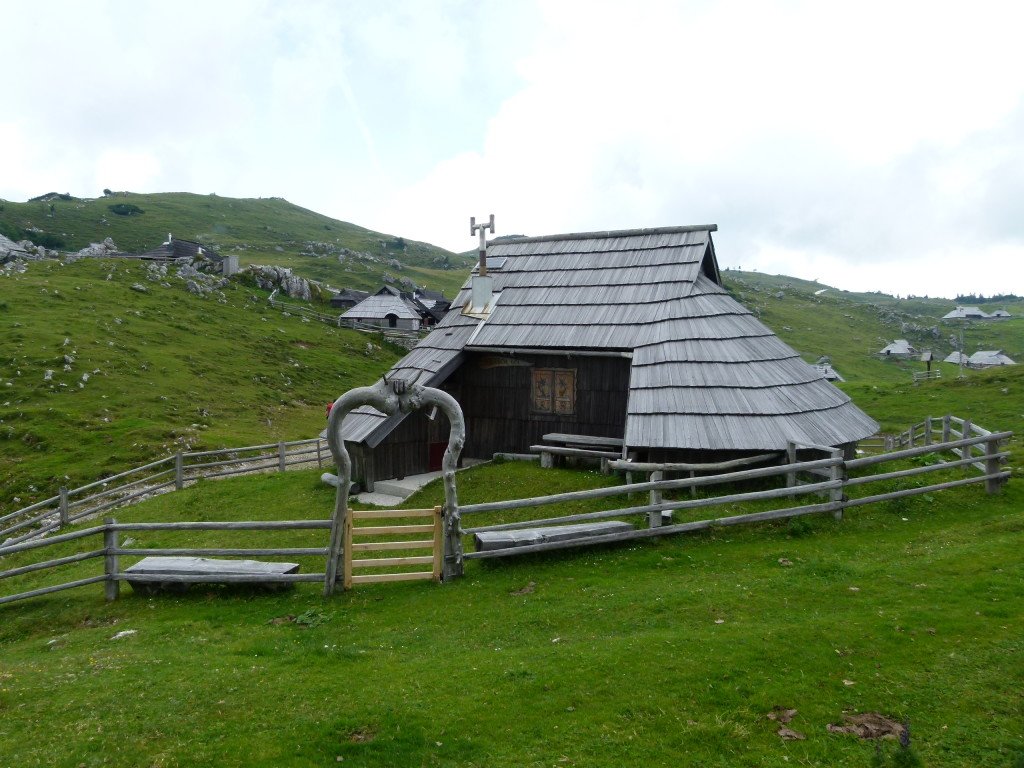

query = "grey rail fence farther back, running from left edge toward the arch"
[0,437,331,545]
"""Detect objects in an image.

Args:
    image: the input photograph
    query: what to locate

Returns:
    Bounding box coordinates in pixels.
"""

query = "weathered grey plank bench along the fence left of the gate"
[125,557,299,594]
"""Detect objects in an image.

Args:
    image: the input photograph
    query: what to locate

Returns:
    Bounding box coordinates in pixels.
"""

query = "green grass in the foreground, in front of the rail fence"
[0,464,1024,766]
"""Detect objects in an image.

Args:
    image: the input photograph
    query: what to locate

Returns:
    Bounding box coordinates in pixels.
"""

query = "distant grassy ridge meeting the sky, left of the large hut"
[0,193,473,296]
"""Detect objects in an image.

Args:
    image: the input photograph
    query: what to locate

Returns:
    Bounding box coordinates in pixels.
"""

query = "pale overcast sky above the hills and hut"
[0,0,1024,296]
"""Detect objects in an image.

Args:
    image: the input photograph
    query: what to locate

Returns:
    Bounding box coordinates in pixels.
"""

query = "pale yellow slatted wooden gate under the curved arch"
[342,507,443,590]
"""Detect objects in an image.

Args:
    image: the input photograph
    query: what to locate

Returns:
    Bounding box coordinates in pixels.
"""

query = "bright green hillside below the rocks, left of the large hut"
[0,259,400,518]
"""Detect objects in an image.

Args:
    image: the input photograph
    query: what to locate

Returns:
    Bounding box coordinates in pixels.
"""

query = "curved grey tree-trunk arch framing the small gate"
[324,379,466,595]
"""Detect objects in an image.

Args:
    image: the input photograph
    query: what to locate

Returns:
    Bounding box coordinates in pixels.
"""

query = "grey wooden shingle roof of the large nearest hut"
[344,225,878,451]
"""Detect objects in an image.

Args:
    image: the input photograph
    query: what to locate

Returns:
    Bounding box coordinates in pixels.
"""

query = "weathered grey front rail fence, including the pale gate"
[0,417,1013,604]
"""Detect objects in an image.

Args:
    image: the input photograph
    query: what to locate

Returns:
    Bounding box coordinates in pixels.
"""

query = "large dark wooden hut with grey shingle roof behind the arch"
[343,225,878,484]
